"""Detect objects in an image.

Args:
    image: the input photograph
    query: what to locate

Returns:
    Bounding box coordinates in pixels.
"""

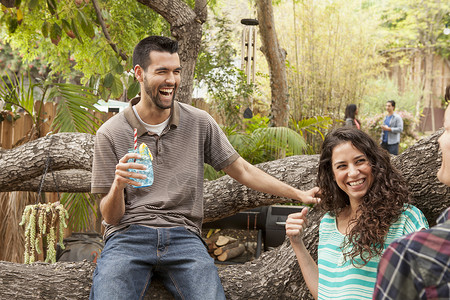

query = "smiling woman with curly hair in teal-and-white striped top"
[286,127,428,300]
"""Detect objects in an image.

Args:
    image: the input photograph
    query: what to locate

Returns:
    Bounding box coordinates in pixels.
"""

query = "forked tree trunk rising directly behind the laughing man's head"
[137,0,208,103]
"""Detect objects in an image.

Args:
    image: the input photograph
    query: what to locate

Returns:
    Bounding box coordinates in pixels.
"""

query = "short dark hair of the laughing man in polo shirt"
[133,35,178,71]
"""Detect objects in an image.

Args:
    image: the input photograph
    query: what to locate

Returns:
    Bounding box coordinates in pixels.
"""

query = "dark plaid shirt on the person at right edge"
[373,207,450,300]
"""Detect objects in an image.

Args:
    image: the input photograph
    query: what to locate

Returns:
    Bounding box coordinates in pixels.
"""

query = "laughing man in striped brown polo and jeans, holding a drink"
[90,36,318,300]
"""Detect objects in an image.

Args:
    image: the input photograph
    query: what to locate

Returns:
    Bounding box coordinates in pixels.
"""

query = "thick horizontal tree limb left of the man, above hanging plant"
[0,133,94,192]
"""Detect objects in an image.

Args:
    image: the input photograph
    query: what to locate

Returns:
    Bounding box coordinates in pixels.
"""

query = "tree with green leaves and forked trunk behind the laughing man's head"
[0,0,207,103]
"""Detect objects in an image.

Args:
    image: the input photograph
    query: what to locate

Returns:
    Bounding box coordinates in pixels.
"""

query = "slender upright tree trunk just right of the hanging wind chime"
[256,0,289,127]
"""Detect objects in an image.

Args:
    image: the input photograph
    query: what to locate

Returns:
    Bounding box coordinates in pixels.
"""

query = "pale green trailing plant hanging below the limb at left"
[19,202,69,264]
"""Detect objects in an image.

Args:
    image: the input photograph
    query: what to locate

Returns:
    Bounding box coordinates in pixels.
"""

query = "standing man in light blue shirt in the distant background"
[381,100,403,155]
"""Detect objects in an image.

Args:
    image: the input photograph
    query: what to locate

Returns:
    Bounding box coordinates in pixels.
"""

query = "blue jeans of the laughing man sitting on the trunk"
[90,225,225,300]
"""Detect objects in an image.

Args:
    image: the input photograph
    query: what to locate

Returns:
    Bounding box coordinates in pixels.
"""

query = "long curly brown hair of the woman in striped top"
[317,127,411,266]
